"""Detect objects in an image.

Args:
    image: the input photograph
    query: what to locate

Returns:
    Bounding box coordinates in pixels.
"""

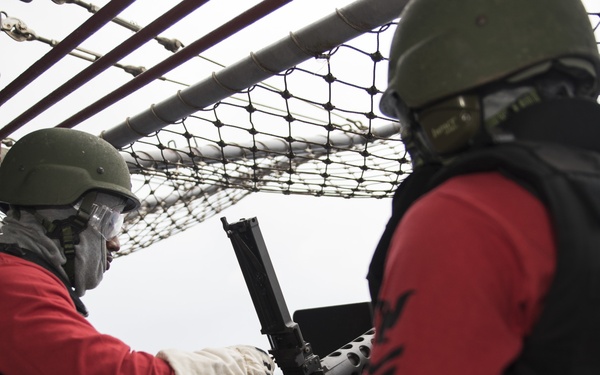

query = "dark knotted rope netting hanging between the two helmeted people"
[120,23,410,255]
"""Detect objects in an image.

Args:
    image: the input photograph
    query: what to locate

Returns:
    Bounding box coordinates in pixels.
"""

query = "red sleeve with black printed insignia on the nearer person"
[372,172,556,375]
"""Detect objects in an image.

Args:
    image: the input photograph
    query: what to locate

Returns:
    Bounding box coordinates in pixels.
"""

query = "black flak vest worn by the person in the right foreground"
[368,100,600,375]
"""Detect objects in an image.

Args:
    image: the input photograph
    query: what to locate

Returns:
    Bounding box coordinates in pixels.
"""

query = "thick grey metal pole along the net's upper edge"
[101,0,407,148]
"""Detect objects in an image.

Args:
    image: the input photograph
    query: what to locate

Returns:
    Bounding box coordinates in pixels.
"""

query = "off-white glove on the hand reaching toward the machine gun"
[156,345,275,375]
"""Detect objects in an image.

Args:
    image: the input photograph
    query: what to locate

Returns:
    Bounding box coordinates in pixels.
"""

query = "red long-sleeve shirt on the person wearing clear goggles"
[0,253,173,375]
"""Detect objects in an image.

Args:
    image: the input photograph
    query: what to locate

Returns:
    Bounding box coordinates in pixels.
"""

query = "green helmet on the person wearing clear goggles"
[0,128,140,212]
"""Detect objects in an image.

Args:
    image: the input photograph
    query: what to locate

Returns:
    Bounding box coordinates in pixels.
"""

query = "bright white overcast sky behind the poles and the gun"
[0,0,390,353]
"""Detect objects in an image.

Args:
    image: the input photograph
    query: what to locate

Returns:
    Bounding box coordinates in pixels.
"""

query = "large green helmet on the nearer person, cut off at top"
[380,0,600,117]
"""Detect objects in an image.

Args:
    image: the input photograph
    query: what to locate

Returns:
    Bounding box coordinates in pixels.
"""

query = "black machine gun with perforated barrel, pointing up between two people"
[221,217,374,375]
